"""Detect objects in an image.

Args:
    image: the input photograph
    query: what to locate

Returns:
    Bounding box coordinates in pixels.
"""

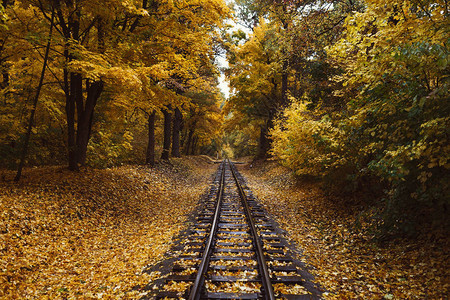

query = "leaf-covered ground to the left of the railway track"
[0,157,217,299]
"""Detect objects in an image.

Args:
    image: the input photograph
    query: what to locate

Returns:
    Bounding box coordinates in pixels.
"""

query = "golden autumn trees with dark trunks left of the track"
[0,0,230,175]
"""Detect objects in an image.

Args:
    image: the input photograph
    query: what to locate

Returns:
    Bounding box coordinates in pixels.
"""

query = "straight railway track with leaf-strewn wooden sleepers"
[149,160,318,300]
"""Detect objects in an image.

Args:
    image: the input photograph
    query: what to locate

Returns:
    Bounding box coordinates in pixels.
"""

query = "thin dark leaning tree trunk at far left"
[14,9,55,181]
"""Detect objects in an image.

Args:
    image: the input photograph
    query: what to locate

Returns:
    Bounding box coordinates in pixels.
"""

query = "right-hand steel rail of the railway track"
[228,160,275,300]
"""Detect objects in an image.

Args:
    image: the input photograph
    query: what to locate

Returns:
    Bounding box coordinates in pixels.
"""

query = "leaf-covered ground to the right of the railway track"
[239,162,450,299]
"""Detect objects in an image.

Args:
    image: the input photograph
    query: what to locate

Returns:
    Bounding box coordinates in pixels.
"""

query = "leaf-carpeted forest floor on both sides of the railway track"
[0,157,450,299]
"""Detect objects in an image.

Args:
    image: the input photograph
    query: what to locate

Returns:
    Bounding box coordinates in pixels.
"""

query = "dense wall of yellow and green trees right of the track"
[226,0,450,233]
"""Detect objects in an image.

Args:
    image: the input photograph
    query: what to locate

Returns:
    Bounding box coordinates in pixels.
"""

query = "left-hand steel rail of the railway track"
[189,161,226,300]
